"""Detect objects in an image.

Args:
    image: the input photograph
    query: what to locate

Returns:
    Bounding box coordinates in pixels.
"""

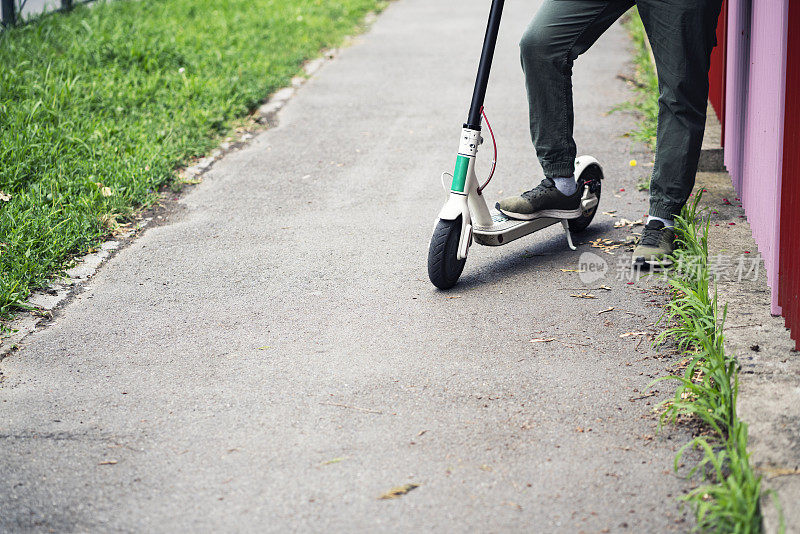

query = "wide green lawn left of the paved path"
[0,0,383,319]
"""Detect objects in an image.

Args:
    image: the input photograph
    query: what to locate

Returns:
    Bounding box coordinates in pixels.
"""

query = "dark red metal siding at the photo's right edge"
[778,1,800,350]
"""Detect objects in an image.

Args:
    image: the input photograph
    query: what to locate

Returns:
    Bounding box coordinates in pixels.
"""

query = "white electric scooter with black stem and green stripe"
[428,0,603,289]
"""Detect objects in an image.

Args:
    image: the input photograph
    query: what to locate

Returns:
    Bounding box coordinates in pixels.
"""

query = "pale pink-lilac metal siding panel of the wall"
[725,0,789,314]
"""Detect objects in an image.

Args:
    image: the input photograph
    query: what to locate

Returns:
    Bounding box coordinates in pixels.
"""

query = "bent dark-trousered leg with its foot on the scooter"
[520,0,633,178]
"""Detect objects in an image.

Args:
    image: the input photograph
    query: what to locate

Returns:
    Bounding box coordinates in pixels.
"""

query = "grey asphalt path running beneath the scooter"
[0,0,691,532]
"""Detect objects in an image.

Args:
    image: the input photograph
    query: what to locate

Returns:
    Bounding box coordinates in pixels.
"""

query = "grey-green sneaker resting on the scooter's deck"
[495,178,583,220]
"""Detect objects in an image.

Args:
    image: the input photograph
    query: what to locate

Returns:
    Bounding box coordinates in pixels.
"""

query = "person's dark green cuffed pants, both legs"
[520,0,722,219]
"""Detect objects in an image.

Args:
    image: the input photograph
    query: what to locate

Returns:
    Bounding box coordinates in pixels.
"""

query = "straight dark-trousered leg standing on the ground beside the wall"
[637,0,722,221]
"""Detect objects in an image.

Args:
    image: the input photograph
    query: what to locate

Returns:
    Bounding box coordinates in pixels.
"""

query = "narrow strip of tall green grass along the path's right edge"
[656,195,783,533]
